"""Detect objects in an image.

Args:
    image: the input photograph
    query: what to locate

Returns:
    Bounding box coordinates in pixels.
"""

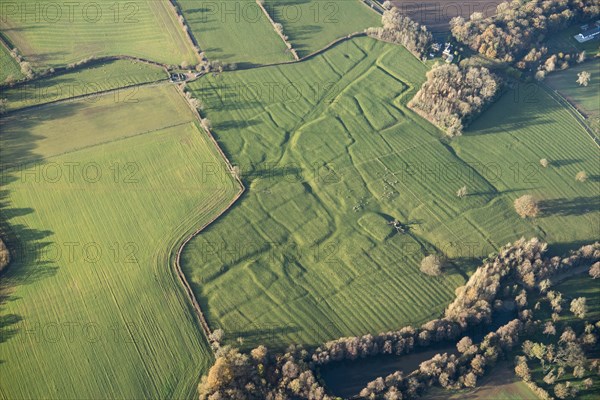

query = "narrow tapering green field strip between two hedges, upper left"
[2,60,167,111]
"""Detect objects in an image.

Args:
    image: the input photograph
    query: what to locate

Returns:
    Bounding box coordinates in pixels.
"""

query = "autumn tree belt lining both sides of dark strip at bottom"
[199,238,600,400]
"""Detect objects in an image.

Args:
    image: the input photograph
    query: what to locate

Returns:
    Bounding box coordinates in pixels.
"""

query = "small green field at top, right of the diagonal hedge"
[265,0,381,57]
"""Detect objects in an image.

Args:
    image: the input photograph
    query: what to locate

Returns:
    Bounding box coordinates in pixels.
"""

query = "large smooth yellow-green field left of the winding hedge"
[0,85,238,399]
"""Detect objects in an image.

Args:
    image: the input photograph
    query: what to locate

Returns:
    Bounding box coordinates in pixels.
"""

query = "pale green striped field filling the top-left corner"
[0,0,197,68]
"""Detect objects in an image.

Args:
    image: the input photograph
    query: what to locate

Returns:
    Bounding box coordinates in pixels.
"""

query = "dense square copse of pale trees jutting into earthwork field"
[409,65,500,137]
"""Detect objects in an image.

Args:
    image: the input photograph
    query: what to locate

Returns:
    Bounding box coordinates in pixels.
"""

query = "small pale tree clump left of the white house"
[366,7,433,58]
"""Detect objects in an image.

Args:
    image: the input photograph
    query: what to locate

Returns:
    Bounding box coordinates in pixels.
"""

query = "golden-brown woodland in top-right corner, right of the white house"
[450,0,600,63]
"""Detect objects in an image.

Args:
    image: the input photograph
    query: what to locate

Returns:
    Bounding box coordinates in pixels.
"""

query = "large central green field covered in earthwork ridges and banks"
[183,38,600,346]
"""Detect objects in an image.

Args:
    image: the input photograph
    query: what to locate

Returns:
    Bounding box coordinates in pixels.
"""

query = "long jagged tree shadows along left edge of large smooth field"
[0,104,79,356]
